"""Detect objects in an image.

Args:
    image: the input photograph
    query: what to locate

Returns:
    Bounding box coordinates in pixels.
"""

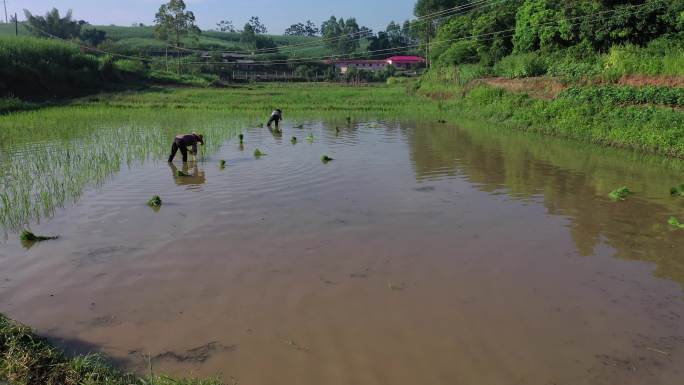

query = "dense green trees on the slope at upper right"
[415,0,684,65]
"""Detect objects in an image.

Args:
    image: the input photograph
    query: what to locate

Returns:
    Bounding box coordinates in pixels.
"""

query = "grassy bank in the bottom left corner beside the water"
[0,314,221,385]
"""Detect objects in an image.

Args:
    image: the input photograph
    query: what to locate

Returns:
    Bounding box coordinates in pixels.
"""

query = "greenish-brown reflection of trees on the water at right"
[407,125,684,286]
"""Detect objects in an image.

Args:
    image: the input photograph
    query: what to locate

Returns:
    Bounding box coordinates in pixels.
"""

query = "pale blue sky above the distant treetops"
[13,0,415,34]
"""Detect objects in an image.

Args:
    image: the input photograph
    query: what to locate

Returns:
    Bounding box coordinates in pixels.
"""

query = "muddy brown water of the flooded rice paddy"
[0,118,684,385]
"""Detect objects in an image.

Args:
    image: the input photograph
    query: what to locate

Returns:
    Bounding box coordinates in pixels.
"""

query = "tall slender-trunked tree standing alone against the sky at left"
[154,0,202,73]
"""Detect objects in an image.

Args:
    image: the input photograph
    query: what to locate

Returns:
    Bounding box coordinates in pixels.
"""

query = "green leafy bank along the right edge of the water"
[419,79,684,158]
